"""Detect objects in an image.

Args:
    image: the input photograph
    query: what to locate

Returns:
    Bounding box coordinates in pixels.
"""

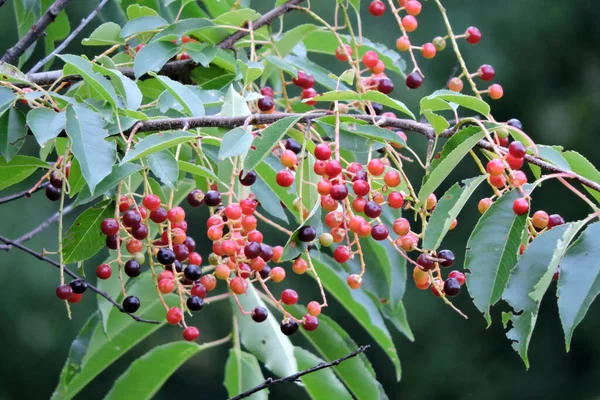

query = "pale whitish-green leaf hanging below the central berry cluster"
[231,285,298,376]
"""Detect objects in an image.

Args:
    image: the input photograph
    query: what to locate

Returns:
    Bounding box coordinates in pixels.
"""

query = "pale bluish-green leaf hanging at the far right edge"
[550,223,600,351]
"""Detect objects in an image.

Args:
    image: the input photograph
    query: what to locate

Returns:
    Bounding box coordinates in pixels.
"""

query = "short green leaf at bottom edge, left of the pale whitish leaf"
[223,349,269,400]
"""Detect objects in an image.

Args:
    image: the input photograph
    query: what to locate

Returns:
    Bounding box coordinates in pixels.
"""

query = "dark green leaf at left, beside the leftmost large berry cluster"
[63,200,115,264]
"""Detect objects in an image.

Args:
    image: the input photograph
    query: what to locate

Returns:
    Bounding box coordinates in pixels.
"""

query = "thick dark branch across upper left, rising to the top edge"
[22,0,304,85]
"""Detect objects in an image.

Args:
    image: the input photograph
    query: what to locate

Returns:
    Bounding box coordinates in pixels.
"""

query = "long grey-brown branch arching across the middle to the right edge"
[125,112,600,192]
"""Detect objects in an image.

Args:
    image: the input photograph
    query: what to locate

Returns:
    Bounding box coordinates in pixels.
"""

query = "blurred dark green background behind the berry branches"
[0,0,600,400]
